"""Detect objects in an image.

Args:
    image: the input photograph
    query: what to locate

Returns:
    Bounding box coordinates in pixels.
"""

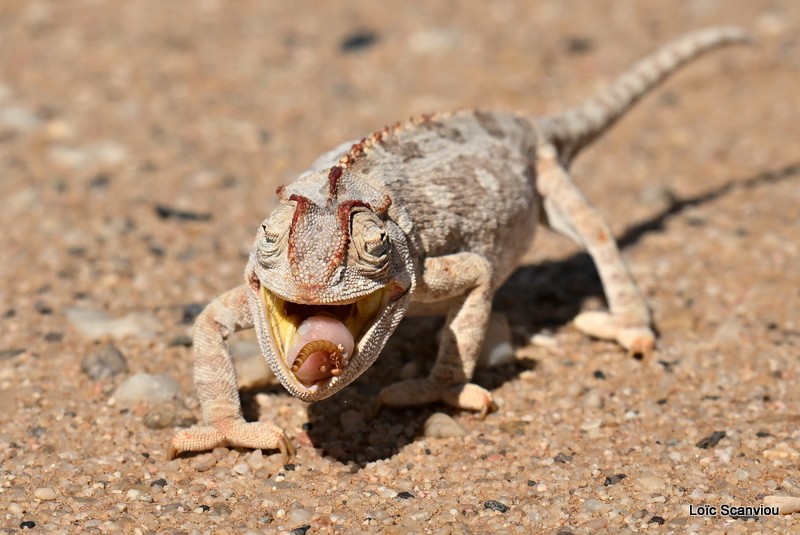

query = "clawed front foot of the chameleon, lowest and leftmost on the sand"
[167,420,295,462]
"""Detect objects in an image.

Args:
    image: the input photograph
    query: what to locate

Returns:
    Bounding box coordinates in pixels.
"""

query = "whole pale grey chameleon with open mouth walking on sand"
[168,27,750,458]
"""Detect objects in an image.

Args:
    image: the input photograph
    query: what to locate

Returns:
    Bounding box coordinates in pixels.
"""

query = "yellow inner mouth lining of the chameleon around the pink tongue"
[261,286,388,378]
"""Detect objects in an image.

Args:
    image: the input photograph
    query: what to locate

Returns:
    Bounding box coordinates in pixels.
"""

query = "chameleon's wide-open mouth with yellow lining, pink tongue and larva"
[261,286,389,390]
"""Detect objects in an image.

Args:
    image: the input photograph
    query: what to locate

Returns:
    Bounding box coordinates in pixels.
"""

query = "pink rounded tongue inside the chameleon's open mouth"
[286,316,355,384]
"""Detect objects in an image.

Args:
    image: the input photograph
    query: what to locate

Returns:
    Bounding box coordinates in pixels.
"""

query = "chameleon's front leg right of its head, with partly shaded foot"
[378,253,494,415]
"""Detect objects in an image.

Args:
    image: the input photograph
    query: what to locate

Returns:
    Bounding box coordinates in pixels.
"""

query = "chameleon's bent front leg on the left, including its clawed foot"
[168,284,294,459]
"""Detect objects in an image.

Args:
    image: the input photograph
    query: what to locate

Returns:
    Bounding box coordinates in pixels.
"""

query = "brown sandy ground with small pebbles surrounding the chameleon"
[0,0,800,534]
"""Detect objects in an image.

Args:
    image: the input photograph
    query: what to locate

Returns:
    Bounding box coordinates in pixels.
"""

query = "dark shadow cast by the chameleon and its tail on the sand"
[308,162,800,469]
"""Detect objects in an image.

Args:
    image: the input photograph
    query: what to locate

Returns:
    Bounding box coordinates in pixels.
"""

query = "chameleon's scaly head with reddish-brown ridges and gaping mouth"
[245,167,414,401]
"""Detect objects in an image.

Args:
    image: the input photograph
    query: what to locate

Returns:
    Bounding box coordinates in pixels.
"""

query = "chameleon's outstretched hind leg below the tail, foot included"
[536,145,655,355]
